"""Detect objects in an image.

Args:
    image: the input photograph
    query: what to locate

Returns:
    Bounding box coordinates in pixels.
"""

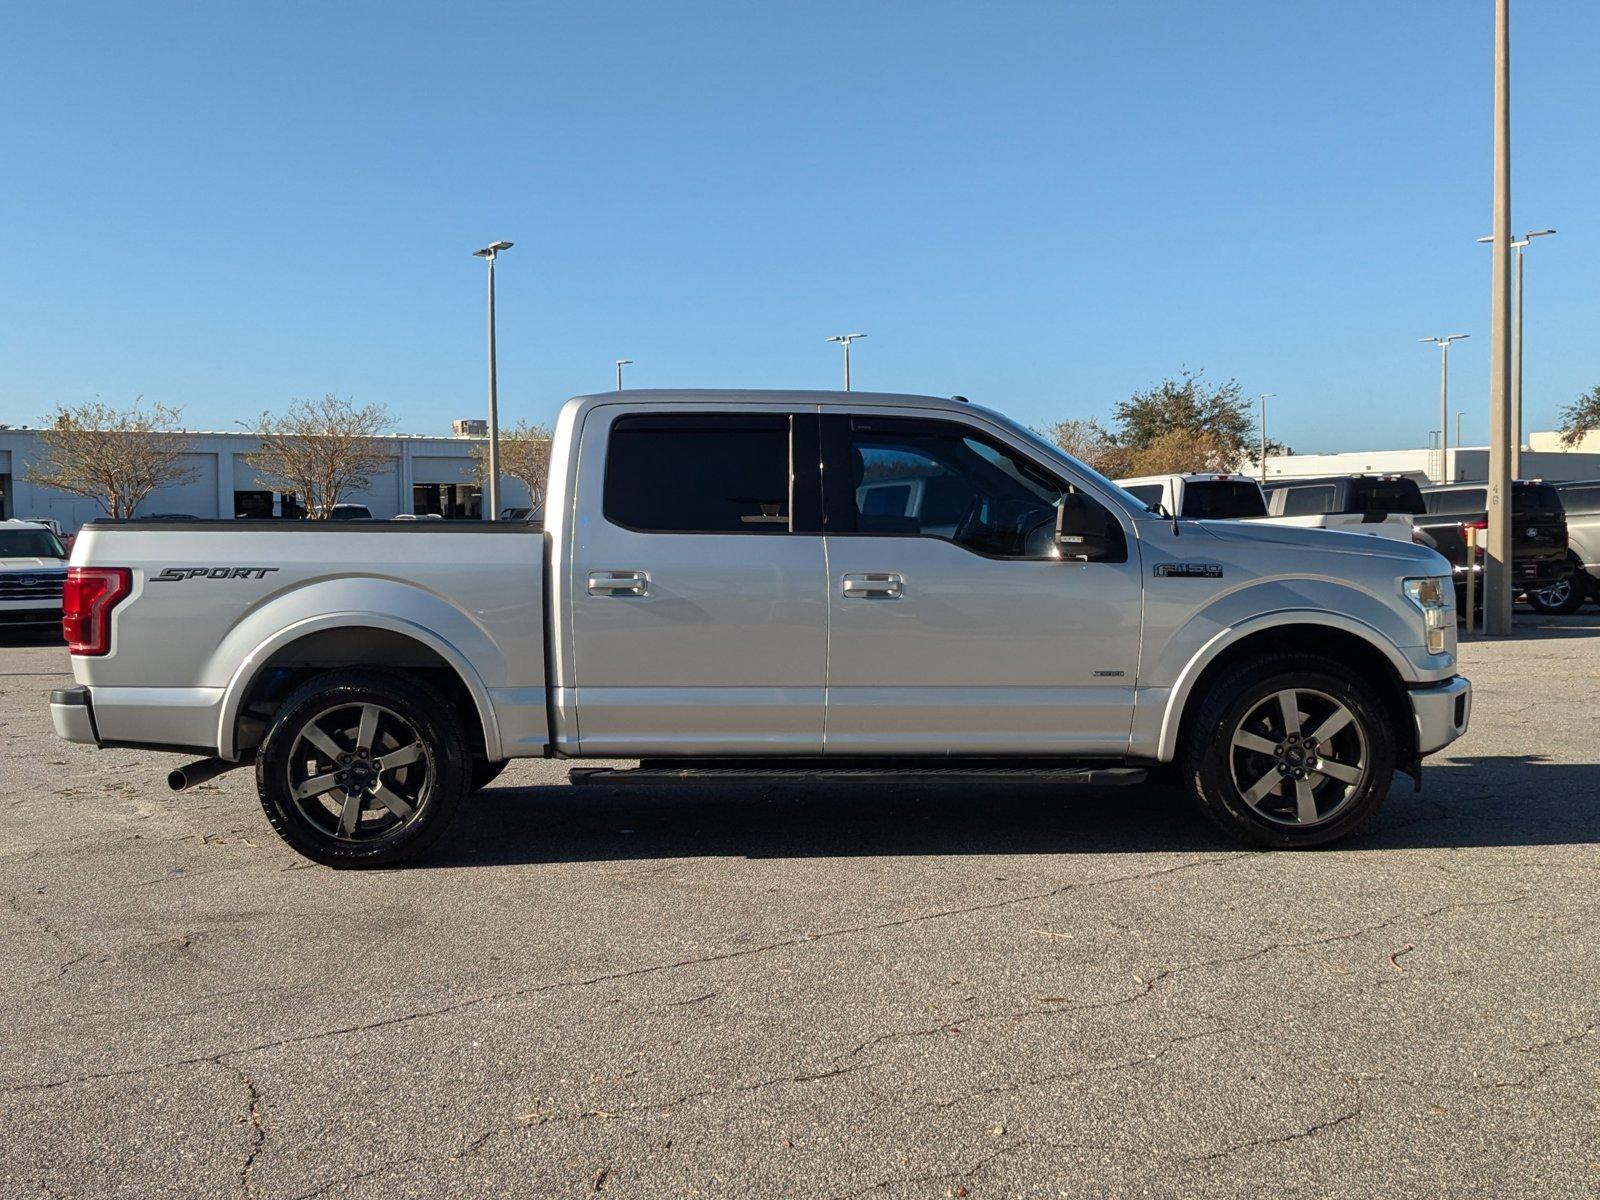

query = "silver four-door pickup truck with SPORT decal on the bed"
[51,390,1470,866]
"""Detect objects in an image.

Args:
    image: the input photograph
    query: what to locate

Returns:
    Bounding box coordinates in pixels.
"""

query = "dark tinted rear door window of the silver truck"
[605,414,789,533]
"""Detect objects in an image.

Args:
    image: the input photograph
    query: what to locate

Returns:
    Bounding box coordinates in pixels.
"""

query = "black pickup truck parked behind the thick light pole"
[1416,480,1571,600]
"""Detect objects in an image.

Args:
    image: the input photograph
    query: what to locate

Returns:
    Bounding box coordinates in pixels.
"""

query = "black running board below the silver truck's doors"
[566,763,1149,787]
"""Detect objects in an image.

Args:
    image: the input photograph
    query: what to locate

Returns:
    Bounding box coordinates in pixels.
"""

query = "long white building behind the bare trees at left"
[0,429,528,533]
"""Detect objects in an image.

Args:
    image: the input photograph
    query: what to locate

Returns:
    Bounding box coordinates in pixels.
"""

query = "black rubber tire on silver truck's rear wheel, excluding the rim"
[256,670,472,867]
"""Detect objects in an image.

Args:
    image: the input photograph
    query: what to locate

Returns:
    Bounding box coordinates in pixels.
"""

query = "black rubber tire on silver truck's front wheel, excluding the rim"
[1186,656,1397,850]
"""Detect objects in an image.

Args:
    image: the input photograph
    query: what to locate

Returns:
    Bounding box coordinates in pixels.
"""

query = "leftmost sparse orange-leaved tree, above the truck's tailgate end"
[24,397,198,520]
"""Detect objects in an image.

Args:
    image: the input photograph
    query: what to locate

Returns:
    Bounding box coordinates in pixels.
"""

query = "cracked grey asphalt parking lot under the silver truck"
[0,611,1600,1198]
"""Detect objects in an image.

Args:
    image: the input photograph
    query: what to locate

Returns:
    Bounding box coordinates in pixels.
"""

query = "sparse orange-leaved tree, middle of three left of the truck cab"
[245,392,394,520]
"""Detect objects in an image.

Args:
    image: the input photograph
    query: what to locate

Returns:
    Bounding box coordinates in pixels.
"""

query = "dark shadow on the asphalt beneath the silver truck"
[419,757,1600,867]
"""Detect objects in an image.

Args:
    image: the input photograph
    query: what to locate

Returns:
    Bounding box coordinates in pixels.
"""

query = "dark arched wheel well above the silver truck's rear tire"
[234,626,485,757]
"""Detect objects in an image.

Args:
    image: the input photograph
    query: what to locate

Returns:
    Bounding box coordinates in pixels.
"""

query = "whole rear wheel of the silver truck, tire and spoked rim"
[256,667,472,867]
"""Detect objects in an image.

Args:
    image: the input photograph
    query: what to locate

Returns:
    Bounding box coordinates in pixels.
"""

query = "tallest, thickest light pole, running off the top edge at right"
[1469,0,1512,637]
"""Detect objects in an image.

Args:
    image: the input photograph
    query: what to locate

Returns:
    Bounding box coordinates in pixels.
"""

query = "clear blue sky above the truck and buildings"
[0,0,1600,450]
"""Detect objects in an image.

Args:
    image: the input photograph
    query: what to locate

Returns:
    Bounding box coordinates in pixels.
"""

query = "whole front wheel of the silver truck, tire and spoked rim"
[1181,654,1395,850]
